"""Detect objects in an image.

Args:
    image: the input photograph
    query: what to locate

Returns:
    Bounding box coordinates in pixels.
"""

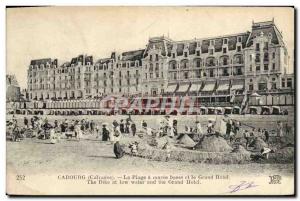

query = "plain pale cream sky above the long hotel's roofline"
[6,7,294,88]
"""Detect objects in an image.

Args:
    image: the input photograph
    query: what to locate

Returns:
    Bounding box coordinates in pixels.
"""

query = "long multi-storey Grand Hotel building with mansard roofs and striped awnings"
[27,21,294,114]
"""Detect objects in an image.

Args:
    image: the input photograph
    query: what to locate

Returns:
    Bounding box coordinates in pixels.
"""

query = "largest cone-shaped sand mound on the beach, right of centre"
[194,135,232,152]
